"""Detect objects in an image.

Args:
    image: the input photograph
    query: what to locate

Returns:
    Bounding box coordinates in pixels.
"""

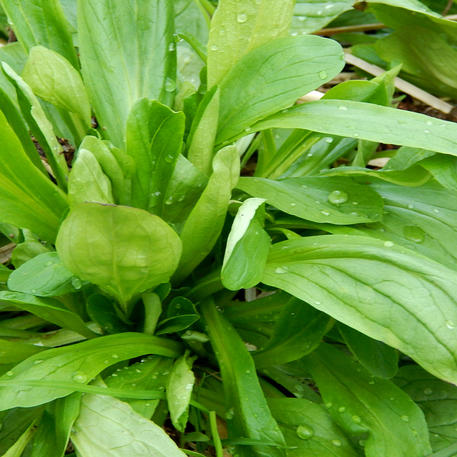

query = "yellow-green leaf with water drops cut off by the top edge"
[208,0,295,87]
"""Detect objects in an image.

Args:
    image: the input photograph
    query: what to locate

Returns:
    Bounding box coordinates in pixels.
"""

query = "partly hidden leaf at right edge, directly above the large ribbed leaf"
[360,182,457,269]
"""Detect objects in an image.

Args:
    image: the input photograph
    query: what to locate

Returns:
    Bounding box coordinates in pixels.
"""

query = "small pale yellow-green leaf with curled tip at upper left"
[22,46,91,124]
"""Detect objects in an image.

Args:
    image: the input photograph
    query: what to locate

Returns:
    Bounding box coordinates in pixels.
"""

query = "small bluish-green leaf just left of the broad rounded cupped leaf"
[8,252,78,297]
